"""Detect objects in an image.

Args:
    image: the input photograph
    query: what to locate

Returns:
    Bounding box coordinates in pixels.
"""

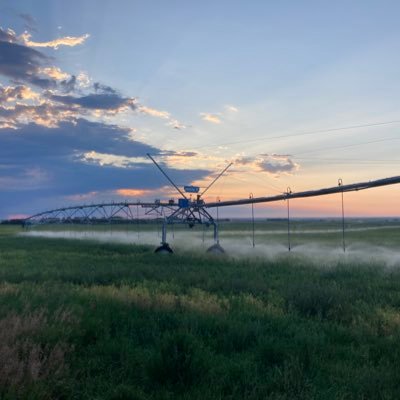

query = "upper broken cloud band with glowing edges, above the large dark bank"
[0,28,186,129]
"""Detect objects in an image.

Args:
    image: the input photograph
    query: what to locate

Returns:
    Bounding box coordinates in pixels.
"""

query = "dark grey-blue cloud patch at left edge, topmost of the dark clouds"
[0,37,56,89]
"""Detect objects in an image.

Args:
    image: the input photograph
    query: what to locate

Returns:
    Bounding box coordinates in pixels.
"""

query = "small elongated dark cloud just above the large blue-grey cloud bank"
[47,93,136,111]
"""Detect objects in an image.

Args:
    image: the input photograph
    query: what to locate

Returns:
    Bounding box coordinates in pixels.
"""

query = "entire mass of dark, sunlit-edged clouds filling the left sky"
[0,23,202,215]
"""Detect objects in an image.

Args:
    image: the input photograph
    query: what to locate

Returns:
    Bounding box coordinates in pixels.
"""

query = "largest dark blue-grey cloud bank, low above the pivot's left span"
[0,119,209,217]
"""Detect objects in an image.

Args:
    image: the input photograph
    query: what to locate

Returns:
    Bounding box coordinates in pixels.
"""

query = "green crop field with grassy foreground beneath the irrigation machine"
[0,220,400,400]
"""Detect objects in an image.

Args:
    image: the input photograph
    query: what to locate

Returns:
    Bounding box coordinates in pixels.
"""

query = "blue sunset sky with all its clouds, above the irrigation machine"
[0,0,400,218]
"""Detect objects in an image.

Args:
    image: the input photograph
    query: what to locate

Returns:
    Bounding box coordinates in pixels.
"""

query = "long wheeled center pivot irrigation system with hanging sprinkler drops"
[25,154,400,253]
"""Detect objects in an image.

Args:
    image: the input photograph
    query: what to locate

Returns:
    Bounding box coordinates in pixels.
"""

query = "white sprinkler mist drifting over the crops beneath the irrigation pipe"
[23,227,400,267]
